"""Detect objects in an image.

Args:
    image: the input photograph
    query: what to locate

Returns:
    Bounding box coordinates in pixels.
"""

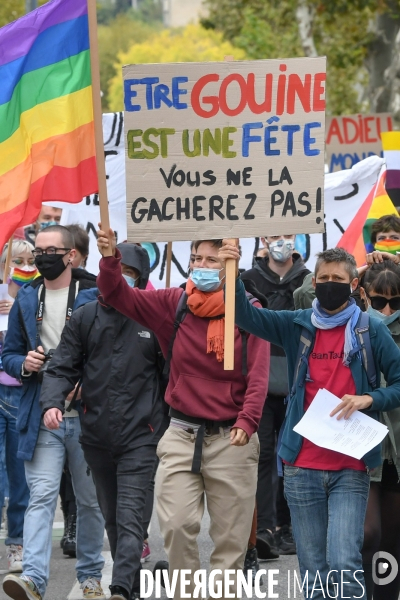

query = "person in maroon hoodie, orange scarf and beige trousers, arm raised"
[98,229,269,600]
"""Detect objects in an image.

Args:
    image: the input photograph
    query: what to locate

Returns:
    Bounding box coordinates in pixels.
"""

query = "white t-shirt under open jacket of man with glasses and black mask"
[38,282,79,417]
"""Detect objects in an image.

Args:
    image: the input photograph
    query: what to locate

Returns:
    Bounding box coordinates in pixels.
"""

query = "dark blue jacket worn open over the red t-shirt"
[235,279,400,468]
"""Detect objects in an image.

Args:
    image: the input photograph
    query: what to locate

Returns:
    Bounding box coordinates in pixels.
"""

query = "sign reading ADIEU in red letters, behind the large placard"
[326,113,393,173]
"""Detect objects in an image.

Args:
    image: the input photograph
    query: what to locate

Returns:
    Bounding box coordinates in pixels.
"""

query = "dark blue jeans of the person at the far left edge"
[0,384,29,546]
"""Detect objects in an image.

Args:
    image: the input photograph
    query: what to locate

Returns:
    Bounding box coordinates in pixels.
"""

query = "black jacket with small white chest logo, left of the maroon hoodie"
[40,299,163,455]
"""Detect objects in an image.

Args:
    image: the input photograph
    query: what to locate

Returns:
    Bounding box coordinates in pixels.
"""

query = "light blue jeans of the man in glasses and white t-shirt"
[22,417,104,596]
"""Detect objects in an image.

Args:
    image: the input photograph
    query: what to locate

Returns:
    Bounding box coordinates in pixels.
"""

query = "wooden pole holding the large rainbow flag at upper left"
[87,0,112,256]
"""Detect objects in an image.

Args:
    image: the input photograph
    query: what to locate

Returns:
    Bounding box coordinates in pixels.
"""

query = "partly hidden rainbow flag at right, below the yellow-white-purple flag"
[337,166,398,267]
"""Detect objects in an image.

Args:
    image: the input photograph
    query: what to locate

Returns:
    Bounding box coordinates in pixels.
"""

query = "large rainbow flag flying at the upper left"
[0,0,98,250]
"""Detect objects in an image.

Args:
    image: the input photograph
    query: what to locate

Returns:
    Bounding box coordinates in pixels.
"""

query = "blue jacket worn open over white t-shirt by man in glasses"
[2,283,98,460]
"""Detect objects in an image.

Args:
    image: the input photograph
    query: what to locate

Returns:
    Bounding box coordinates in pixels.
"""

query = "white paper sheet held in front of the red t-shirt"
[293,389,389,459]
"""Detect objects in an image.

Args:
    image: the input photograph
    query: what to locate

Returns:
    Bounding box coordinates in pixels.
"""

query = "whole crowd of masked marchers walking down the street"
[0,207,400,600]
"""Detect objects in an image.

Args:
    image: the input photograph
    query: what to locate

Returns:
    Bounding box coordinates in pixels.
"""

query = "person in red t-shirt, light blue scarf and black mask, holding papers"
[219,244,400,600]
